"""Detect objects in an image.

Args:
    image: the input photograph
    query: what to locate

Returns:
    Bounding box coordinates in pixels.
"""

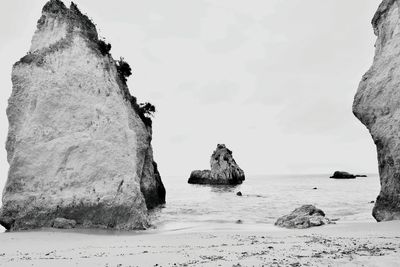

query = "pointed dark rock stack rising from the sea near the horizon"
[188,144,245,185]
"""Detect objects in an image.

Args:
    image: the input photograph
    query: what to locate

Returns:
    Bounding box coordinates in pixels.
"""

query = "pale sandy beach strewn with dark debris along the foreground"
[0,221,400,266]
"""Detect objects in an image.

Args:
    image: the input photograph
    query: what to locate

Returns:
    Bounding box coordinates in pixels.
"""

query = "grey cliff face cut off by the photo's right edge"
[353,0,400,221]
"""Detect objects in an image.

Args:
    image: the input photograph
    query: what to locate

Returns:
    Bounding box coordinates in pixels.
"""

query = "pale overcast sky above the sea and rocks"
[0,0,380,191]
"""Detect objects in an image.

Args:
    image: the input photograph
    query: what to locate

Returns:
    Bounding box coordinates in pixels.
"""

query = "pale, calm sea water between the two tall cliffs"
[151,174,380,231]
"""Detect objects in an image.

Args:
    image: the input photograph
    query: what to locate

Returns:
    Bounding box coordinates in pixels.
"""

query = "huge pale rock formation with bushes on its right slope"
[0,0,165,230]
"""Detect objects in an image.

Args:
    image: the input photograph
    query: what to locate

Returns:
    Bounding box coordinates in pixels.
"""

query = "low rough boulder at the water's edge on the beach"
[275,205,331,229]
